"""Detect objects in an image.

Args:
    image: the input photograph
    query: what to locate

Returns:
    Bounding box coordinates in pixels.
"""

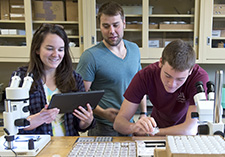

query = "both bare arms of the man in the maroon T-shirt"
[113,99,198,135]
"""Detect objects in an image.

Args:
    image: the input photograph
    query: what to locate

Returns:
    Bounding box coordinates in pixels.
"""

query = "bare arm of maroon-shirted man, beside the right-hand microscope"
[157,105,198,135]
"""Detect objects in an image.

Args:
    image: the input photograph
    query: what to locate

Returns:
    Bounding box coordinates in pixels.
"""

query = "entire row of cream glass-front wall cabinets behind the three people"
[0,0,225,63]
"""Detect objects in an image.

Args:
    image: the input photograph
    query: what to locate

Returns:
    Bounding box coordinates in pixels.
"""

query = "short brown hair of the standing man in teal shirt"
[97,1,125,23]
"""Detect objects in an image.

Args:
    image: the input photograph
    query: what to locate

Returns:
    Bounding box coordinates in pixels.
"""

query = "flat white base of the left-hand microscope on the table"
[0,135,51,156]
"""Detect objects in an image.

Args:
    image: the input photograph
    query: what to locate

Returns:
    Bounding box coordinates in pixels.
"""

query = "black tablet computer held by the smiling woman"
[48,90,104,113]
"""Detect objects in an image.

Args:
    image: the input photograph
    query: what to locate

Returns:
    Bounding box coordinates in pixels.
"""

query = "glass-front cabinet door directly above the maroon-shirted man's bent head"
[148,0,200,62]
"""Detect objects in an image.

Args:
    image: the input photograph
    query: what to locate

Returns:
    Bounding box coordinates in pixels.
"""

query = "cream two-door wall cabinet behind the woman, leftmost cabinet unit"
[0,0,83,62]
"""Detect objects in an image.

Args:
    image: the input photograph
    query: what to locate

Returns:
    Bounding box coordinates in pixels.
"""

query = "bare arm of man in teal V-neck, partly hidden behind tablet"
[84,80,119,122]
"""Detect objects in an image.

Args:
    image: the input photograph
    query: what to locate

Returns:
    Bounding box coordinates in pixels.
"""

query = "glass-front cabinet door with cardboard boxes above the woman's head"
[31,0,83,61]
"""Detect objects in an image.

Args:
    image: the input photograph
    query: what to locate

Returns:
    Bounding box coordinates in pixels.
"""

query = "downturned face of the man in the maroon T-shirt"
[159,61,191,93]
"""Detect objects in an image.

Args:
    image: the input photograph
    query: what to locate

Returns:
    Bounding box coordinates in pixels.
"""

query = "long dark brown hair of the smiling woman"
[28,23,77,93]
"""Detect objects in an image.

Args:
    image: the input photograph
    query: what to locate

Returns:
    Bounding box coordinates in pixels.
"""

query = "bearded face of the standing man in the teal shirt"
[100,14,125,46]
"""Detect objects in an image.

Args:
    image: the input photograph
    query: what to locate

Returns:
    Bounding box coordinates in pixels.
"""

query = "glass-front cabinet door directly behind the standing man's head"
[90,0,143,57]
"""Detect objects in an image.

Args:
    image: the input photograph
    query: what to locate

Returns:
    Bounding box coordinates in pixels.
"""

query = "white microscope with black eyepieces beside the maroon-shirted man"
[191,70,224,137]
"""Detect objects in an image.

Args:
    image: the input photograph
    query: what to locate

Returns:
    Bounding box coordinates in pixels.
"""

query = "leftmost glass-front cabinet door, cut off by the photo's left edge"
[0,0,29,61]
